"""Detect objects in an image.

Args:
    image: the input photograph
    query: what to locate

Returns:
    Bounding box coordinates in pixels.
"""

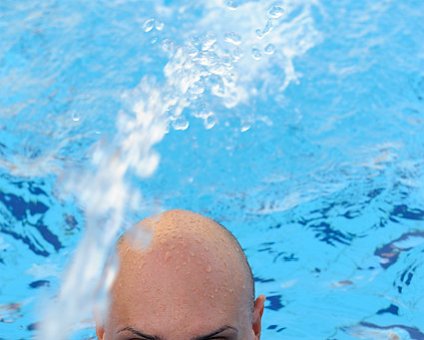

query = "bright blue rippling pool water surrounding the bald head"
[0,0,424,340]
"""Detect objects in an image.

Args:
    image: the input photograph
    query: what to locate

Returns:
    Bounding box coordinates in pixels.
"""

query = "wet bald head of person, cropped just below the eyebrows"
[97,210,265,340]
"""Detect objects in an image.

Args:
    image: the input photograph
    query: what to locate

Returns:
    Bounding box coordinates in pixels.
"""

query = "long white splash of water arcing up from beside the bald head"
[27,1,317,340]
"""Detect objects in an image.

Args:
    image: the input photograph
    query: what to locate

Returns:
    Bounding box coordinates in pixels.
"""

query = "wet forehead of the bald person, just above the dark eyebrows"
[111,235,244,335]
